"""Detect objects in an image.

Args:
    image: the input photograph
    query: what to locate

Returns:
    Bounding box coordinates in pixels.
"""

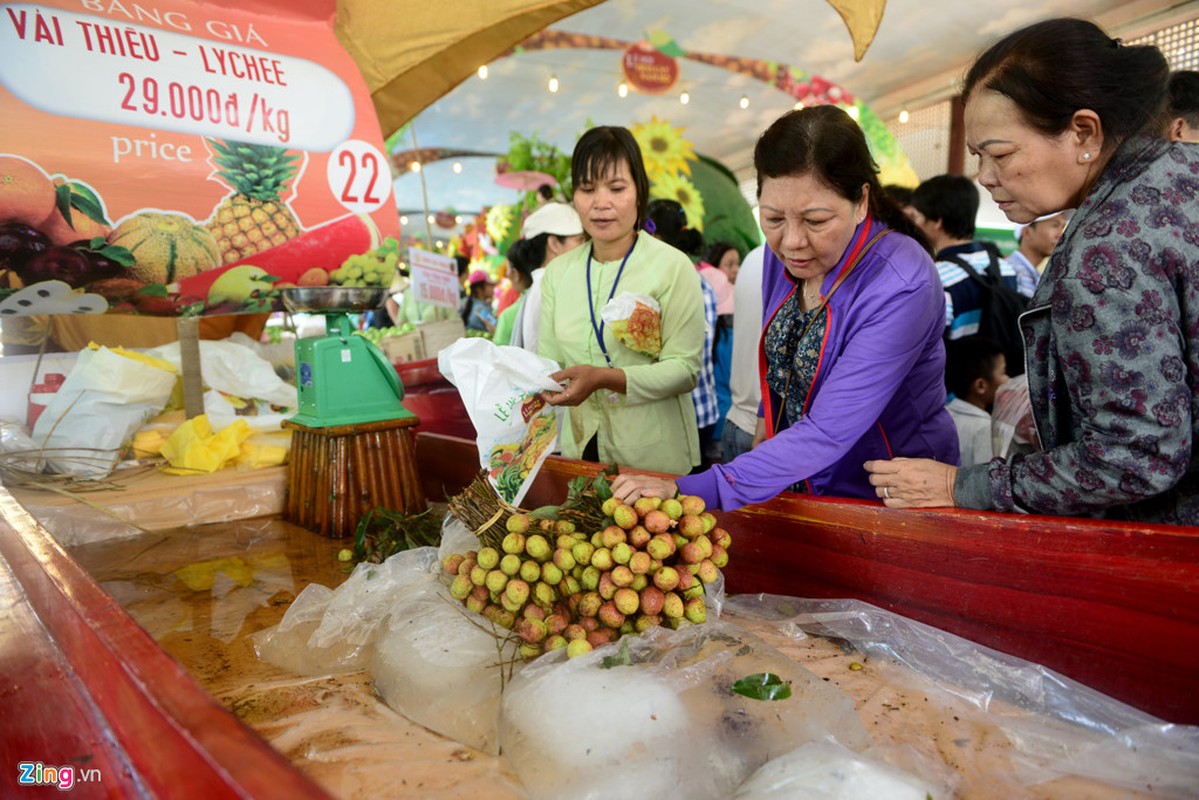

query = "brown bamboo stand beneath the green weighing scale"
[283,416,424,539]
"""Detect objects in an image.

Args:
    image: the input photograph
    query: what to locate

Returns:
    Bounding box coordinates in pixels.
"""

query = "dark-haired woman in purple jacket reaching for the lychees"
[613,106,958,510]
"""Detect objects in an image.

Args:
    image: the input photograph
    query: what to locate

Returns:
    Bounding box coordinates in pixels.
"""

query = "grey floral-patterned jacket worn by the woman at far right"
[954,138,1199,525]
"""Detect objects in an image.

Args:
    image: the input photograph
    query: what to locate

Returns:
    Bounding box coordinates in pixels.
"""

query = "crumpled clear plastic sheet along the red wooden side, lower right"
[725,595,1199,799]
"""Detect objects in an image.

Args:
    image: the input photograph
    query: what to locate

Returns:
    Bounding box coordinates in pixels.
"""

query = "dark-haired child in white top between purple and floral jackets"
[945,335,1007,467]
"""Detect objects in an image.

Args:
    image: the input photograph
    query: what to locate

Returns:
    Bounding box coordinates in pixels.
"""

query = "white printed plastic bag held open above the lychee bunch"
[438,338,562,506]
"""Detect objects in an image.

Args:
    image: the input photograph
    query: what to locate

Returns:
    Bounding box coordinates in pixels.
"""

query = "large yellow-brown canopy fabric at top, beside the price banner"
[335,0,603,137]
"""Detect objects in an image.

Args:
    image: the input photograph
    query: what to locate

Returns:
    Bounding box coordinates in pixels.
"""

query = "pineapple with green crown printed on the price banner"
[205,139,300,264]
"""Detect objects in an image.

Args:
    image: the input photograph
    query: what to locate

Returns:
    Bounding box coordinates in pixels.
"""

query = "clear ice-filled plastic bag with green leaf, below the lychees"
[500,621,869,799]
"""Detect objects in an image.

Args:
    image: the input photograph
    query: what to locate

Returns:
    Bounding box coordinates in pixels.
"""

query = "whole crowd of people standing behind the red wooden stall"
[388,18,1199,524]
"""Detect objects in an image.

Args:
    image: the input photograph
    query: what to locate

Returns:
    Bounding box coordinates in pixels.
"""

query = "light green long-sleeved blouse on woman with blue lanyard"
[538,227,704,475]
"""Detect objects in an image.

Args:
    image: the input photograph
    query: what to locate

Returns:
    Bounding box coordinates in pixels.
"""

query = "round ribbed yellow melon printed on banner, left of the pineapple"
[108,211,221,283]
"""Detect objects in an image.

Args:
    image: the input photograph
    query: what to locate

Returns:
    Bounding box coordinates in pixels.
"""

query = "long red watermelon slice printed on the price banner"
[180,213,379,297]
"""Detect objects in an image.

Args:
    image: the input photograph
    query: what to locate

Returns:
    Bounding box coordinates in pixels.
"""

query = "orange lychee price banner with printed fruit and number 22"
[0,0,399,319]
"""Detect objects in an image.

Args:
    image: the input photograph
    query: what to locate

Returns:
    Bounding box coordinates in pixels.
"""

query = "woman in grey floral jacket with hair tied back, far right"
[866,19,1199,525]
